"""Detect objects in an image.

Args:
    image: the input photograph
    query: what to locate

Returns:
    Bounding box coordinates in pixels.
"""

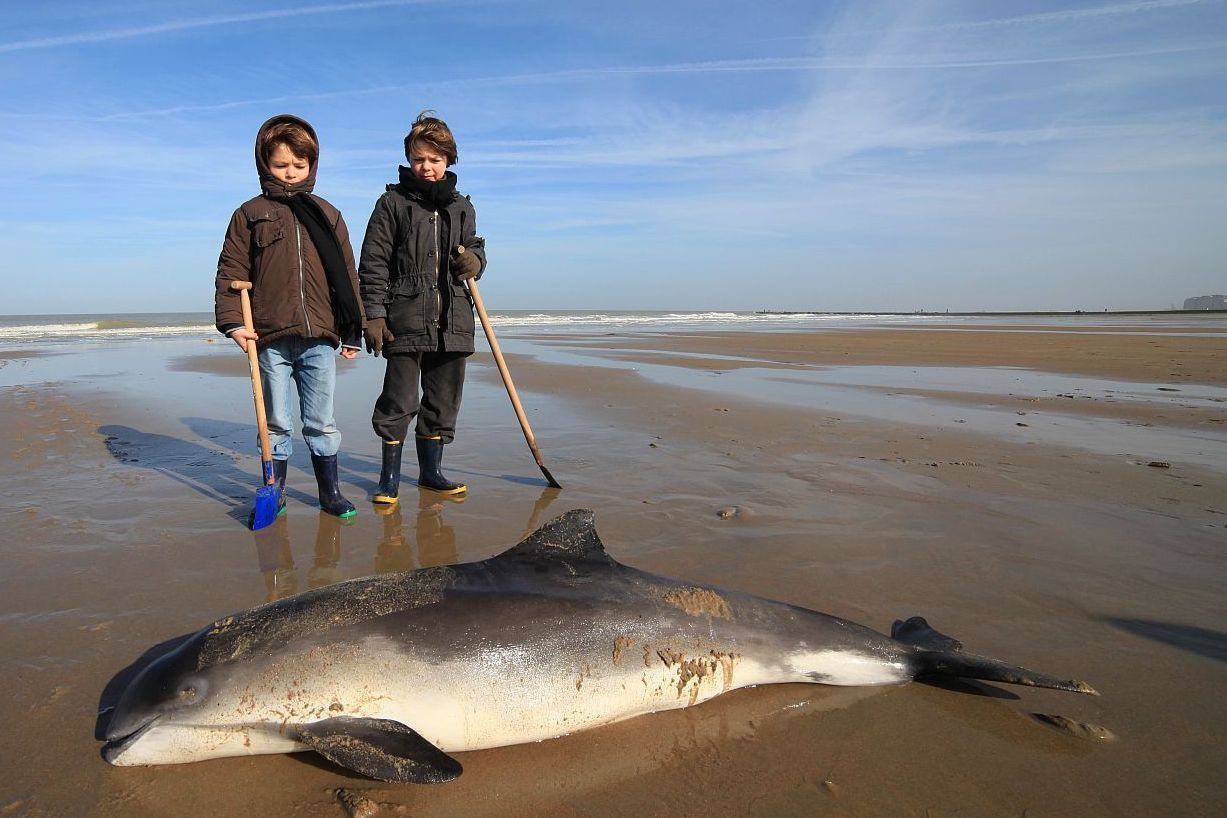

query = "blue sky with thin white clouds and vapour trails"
[0,0,1227,314]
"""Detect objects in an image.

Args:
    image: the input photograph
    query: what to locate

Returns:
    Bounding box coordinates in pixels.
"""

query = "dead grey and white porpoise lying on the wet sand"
[103,510,1094,784]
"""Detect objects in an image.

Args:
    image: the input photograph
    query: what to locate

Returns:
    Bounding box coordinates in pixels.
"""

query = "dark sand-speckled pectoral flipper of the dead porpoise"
[298,716,464,784]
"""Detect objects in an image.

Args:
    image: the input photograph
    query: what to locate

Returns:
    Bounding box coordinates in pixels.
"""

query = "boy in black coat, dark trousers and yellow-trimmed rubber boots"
[358,112,486,504]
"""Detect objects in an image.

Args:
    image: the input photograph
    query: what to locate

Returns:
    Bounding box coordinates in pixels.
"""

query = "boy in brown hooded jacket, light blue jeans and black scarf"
[216,114,363,516]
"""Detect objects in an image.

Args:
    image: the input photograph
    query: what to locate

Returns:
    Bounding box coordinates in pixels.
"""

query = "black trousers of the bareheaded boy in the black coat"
[371,352,472,443]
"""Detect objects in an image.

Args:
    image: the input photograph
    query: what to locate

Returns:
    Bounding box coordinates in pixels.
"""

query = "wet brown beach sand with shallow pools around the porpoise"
[0,318,1227,817]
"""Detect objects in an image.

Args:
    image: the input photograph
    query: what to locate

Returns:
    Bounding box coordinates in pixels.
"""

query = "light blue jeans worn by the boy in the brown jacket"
[259,336,341,460]
